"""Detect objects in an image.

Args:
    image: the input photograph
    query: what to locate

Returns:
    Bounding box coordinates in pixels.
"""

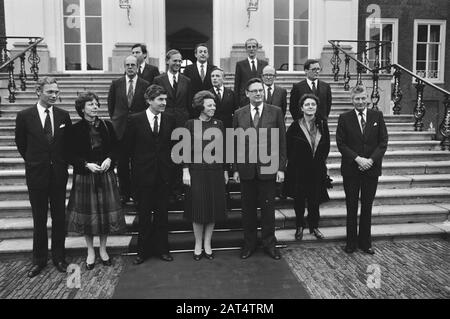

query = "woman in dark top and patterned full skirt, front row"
[66,92,126,270]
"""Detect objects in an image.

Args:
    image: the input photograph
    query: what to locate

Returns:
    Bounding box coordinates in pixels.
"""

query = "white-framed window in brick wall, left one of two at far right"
[366,18,398,72]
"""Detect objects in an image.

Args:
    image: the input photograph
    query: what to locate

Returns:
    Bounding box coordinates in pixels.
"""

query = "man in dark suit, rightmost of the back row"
[234,39,267,107]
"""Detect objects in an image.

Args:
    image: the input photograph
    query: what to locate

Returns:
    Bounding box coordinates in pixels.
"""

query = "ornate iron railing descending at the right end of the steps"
[328,40,450,151]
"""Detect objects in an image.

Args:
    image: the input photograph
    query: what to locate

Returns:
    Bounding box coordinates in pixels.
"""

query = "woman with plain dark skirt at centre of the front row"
[183,91,228,260]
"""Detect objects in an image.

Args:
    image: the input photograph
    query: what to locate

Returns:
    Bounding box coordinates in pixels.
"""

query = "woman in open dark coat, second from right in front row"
[286,94,330,240]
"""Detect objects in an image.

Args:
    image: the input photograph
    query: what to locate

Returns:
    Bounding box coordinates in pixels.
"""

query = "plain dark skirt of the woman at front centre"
[184,168,226,224]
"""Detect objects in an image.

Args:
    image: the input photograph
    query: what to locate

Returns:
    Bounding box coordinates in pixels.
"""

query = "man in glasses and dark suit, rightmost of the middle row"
[289,59,332,120]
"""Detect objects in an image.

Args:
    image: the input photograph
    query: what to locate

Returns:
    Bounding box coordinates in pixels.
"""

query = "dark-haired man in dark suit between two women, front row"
[125,85,176,265]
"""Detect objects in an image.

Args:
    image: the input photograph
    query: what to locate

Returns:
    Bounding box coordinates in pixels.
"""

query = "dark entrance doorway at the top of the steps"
[166,0,213,69]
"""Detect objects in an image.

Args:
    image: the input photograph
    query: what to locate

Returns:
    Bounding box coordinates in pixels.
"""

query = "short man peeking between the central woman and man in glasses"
[210,68,236,128]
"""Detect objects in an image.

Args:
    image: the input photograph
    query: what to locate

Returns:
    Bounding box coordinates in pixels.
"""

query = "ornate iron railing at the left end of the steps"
[0,37,44,103]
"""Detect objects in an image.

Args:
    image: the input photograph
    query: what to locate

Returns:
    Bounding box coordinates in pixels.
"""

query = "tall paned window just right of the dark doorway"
[274,0,309,71]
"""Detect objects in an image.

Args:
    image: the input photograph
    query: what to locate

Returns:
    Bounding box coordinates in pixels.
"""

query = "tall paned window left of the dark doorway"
[62,0,104,72]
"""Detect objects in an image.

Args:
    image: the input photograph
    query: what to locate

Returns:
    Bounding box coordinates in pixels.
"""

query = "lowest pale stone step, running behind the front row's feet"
[0,222,450,258]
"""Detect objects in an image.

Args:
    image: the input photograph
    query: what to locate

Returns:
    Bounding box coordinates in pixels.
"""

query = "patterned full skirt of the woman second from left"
[66,171,126,235]
